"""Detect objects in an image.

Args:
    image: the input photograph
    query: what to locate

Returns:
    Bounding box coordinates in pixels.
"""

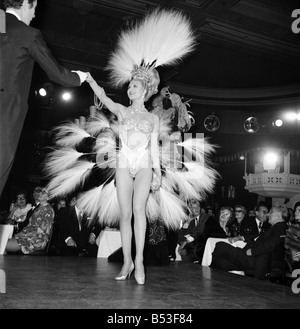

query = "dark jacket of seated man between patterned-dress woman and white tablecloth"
[56,206,101,252]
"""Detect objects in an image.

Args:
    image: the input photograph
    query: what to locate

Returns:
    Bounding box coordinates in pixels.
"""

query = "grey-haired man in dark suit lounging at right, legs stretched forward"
[211,206,287,280]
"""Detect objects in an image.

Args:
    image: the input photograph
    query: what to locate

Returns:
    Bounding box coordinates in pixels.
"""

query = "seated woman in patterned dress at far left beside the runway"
[6,188,54,254]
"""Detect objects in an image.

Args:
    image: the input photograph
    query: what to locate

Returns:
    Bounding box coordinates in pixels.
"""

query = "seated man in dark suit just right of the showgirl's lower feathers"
[178,200,209,262]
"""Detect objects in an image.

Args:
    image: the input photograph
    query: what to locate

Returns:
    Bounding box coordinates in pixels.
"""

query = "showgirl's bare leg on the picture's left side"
[116,168,133,275]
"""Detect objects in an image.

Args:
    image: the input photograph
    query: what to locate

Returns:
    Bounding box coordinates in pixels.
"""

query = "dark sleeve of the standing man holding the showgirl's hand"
[29,29,80,87]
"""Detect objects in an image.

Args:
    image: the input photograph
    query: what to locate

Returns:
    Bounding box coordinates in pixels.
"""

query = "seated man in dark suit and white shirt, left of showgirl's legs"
[56,197,101,257]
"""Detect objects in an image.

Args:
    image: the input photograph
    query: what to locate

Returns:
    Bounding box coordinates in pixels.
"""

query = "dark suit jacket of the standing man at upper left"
[0,14,80,194]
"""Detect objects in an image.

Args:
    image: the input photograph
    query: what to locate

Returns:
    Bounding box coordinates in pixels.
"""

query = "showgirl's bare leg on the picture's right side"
[133,168,152,279]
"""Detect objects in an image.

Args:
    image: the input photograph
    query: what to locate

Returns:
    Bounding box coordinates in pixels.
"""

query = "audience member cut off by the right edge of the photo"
[285,202,300,270]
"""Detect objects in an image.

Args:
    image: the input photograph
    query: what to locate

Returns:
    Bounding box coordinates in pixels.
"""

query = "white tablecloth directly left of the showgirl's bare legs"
[96,229,122,258]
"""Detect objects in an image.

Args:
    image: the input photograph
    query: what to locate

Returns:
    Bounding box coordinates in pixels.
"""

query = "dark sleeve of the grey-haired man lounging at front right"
[251,223,286,257]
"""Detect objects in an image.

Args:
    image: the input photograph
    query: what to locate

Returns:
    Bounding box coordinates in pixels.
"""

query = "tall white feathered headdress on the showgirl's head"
[107,9,195,93]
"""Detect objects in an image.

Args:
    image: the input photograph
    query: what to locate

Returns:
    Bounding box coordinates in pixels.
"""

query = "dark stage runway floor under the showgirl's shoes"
[0,255,300,311]
